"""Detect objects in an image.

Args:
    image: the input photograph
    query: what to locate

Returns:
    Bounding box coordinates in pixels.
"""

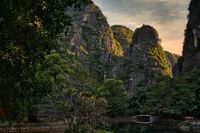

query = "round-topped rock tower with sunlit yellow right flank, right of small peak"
[128,25,172,90]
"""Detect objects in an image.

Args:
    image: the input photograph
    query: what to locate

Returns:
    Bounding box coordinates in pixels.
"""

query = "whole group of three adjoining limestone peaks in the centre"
[67,3,172,90]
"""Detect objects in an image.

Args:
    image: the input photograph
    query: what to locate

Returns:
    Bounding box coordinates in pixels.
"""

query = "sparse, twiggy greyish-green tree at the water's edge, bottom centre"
[56,88,107,133]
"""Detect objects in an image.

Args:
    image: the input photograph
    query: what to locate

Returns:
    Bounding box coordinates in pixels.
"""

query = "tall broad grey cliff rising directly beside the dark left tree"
[66,3,123,77]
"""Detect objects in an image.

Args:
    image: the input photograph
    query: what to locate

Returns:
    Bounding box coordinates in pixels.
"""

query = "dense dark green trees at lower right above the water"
[132,70,200,116]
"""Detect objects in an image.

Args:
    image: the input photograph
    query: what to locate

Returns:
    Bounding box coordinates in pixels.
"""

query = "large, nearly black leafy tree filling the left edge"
[0,0,73,119]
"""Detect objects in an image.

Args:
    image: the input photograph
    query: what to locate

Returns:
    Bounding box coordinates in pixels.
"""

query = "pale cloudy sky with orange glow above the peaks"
[93,0,190,55]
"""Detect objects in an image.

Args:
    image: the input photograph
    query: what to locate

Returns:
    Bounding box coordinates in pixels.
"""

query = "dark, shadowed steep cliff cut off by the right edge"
[183,0,200,72]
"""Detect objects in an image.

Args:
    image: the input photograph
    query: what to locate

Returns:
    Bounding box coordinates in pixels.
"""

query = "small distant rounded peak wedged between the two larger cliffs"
[111,25,134,56]
